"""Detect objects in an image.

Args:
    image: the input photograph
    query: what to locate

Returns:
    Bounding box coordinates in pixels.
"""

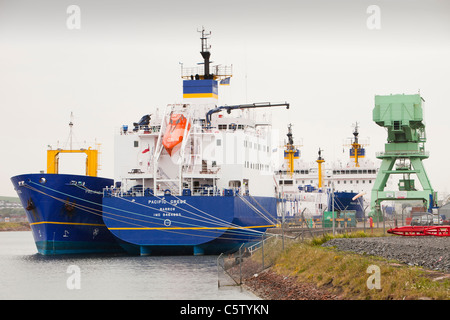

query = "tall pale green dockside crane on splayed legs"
[369,94,437,221]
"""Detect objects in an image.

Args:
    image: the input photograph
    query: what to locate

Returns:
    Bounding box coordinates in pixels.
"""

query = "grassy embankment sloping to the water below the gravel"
[256,232,450,300]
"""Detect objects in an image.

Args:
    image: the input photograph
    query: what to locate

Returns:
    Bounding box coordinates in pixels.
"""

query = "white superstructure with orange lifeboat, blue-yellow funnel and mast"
[111,30,289,197]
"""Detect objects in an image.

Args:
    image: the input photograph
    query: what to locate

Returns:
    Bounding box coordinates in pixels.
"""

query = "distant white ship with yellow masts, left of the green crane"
[275,124,392,219]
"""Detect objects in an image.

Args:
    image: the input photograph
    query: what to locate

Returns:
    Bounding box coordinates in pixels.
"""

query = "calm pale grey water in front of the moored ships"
[0,232,258,300]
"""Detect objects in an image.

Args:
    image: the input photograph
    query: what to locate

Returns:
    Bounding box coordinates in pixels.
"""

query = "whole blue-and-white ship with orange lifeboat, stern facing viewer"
[103,30,289,255]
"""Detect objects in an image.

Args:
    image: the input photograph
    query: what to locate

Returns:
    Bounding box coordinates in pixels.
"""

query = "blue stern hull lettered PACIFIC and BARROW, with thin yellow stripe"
[103,195,276,255]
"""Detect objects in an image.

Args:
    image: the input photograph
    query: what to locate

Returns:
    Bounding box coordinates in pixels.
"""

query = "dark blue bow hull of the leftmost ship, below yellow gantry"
[11,174,123,255]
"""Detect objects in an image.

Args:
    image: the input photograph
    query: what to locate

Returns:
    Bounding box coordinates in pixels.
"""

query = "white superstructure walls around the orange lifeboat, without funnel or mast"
[115,104,288,196]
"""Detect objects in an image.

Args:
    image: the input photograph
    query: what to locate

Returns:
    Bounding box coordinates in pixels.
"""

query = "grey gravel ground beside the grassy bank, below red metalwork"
[323,236,450,272]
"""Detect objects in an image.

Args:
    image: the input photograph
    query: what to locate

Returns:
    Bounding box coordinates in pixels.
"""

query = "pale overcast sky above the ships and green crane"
[0,0,450,196]
